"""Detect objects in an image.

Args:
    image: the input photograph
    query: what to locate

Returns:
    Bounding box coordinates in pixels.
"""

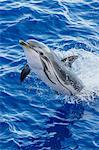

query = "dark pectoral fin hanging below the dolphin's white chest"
[20,64,30,82]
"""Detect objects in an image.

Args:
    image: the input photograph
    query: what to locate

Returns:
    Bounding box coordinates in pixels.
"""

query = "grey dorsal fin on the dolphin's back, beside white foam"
[61,55,78,67]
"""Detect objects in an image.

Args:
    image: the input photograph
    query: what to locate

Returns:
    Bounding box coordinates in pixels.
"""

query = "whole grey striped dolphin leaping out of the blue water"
[19,40,84,95]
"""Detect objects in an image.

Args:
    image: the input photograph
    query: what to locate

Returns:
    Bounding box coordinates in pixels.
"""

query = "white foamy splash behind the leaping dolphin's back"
[56,49,99,101]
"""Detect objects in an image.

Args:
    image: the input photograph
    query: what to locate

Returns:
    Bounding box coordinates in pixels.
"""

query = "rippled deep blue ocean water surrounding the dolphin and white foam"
[0,0,99,150]
